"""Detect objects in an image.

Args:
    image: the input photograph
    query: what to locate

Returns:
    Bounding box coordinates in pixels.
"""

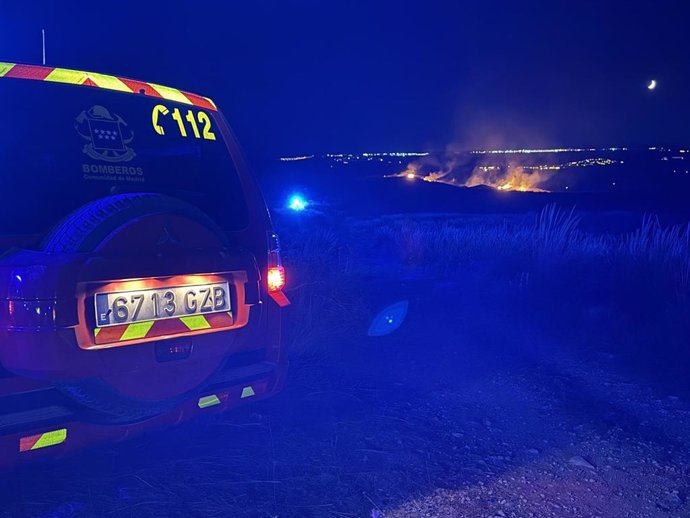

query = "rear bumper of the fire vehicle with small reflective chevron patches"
[0,362,287,469]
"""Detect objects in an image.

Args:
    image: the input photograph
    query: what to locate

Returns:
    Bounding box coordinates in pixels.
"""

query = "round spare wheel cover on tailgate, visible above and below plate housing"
[42,193,235,422]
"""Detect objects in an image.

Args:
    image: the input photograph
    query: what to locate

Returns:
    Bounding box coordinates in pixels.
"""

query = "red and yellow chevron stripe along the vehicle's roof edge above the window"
[0,62,218,111]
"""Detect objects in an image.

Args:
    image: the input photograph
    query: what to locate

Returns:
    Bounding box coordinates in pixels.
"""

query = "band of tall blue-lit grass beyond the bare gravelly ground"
[276,205,690,358]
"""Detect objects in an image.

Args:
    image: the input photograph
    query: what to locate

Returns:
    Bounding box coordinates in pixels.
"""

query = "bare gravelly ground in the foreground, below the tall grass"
[0,288,690,518]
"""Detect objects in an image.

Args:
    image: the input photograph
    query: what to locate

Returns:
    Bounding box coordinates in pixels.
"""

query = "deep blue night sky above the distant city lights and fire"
[0,0,690,158]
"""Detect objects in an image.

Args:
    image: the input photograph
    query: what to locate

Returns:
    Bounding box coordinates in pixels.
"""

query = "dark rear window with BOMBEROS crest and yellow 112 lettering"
[0,78,247,235]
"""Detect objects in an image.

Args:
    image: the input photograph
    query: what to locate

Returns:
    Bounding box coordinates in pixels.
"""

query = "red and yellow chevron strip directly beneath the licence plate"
[94,311,234,345]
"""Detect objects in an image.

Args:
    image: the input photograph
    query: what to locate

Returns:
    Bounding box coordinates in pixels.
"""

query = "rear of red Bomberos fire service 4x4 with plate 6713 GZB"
[0,63,288,465]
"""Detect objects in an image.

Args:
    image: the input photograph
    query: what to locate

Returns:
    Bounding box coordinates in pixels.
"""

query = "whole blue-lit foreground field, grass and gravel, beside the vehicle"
[0,206,690,518]
